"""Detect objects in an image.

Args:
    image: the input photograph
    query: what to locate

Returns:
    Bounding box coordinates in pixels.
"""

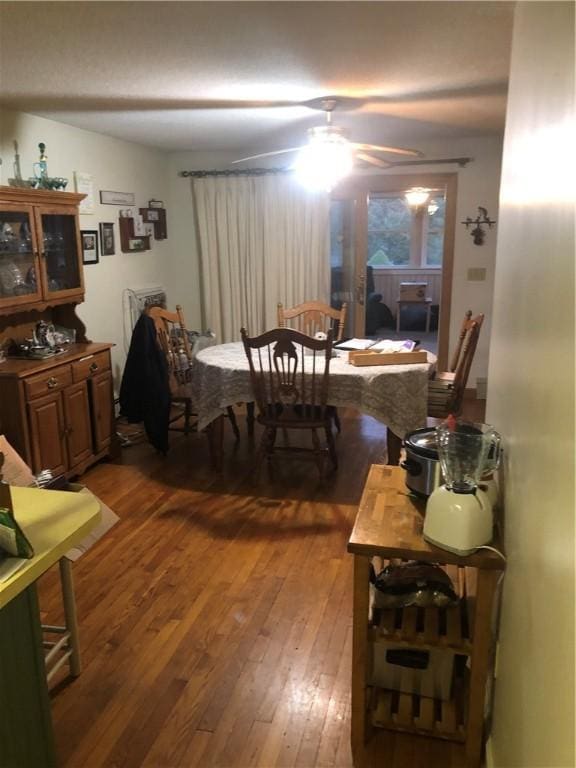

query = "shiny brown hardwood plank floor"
[40,402,484,768]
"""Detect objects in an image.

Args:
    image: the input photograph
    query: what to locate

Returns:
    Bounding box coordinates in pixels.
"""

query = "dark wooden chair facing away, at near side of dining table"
[241,328,338,478]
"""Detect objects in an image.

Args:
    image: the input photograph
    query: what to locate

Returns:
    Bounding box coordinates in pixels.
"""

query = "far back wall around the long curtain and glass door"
[169,137,502,387]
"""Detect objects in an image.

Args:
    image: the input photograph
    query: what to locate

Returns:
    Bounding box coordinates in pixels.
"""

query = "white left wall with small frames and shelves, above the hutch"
[0,111,172,386]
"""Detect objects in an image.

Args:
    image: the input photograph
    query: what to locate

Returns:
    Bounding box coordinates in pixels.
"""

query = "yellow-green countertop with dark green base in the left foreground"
[0,487,100,768]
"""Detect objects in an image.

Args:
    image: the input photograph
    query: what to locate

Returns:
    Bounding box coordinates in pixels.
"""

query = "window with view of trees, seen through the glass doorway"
[368,193,445,269]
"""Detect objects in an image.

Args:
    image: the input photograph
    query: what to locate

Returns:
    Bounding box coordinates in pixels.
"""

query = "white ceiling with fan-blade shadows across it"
[0,1,513,157]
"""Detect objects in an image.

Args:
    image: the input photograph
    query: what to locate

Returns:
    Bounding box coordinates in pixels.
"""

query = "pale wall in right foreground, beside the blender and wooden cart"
[487,2,576,768]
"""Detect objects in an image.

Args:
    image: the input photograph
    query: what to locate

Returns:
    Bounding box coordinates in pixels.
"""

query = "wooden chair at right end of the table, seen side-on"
[428,310,484,419]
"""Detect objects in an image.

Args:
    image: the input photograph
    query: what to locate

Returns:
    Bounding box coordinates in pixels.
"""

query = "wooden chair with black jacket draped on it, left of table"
[146,304,240,440]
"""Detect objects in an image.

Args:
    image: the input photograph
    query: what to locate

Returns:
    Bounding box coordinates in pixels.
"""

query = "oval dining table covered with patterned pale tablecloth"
[191,342,436,467]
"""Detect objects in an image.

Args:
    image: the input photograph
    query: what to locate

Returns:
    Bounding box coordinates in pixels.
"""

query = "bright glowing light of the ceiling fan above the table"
[294,140,354,192]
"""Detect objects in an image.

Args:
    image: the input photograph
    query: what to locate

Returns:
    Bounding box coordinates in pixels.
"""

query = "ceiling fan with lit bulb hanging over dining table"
[227,98,470,190]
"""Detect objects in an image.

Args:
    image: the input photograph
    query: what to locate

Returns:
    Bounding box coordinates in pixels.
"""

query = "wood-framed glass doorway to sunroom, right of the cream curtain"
[331,174,457,365]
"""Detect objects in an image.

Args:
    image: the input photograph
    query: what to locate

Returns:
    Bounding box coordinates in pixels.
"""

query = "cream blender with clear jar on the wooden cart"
[423,418,500,555]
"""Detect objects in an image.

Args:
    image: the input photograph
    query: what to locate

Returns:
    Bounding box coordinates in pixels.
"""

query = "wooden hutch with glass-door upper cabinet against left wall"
[0,187,114,477]
